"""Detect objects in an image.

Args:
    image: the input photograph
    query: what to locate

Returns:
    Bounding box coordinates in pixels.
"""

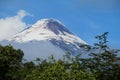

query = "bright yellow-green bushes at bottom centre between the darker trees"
[25,59,95,80]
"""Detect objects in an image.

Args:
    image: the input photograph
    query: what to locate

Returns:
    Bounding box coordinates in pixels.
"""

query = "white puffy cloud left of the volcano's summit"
[0,10,29,41]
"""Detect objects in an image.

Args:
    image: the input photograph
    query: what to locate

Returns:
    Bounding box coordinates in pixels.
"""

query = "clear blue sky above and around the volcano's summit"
[0,0,120,48]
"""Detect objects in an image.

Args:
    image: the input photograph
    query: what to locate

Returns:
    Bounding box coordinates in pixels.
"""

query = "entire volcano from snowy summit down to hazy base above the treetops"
[1,19,86,59]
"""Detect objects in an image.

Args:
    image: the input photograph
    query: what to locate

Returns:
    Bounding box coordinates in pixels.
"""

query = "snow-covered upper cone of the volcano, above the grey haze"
[12,19,86,44]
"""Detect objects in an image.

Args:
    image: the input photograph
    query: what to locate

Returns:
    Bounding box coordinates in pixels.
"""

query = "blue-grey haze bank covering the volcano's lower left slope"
[1,40,65,61]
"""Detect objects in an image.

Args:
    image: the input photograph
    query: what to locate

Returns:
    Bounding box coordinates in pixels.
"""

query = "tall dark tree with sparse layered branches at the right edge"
[81,32,120,80]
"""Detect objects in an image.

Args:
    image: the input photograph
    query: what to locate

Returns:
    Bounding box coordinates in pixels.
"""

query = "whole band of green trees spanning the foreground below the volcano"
[0,32,120,80]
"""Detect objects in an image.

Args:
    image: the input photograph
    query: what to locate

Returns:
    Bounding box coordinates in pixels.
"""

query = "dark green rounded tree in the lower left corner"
[0,45,23,80]
